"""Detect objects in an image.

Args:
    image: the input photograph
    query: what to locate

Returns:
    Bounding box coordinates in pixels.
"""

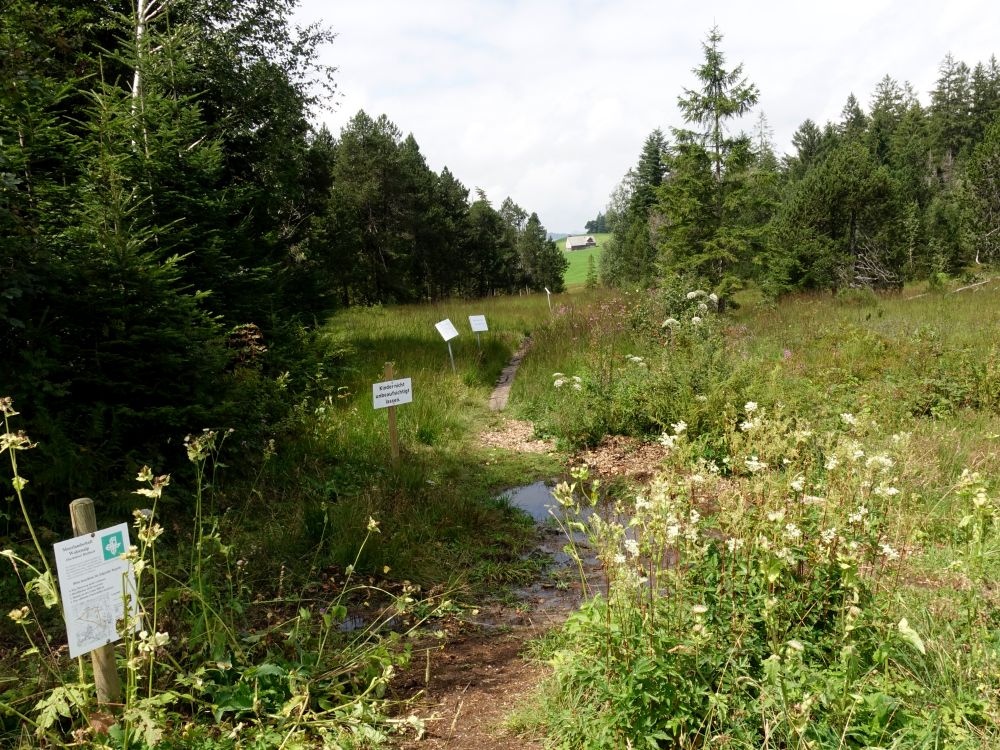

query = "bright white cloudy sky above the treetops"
[293,0,1000,232]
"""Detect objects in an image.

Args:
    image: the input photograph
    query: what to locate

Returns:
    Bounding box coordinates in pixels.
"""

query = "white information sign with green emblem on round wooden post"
[53,523,139,657]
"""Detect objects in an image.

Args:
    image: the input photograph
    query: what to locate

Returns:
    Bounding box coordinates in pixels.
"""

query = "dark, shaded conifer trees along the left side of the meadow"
[0,0,565,506]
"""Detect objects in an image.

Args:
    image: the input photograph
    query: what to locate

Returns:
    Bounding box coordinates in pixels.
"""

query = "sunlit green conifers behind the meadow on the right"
[599,28,1000,296]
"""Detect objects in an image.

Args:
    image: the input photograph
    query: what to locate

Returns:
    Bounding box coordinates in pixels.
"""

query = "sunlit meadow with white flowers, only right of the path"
[513,282,1000,750]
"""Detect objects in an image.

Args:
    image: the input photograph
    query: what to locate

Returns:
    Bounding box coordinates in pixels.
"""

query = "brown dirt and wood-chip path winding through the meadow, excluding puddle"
[394,340,664,750]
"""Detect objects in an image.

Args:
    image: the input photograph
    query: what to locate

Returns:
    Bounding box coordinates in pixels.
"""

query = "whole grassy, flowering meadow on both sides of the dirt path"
[0,278,1000,750]
